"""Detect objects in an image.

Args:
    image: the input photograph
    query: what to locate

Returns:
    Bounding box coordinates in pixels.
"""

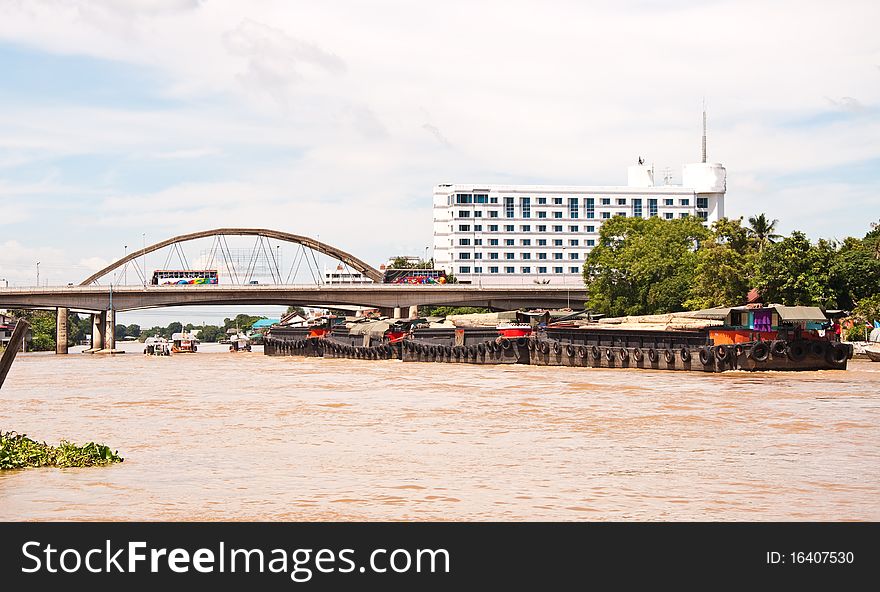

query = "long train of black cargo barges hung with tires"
[264,305,852,372]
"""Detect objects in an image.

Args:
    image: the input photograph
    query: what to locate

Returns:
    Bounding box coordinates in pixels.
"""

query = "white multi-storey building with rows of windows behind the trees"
[434,162,727,285]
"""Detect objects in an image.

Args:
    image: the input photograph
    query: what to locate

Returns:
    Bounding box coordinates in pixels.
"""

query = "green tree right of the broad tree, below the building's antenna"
[685,218,757,309]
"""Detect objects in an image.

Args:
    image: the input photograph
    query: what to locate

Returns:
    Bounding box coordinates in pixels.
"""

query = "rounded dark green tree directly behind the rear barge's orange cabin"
[755,231,837,306]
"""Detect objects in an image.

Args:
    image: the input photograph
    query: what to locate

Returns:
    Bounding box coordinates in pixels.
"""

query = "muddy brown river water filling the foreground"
[0,344,880,521]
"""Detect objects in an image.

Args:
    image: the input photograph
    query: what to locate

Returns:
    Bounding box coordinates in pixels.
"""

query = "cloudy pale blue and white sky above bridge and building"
[0,0,880,324]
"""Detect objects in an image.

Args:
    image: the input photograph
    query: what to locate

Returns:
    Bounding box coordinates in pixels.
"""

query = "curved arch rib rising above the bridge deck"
[80,228,382,286]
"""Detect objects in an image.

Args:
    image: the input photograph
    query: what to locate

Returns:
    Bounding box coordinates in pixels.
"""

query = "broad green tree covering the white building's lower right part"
[584,216,710,316]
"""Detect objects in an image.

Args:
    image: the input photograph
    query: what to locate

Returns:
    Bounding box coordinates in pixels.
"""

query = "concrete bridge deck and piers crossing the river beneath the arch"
[0,284,587,353]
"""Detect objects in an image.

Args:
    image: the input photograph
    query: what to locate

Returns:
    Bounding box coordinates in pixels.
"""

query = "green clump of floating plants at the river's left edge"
[0,430,124,470]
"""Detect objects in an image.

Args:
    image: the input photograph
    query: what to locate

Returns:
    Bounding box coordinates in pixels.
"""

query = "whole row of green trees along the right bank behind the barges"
[583,214,880,321]
